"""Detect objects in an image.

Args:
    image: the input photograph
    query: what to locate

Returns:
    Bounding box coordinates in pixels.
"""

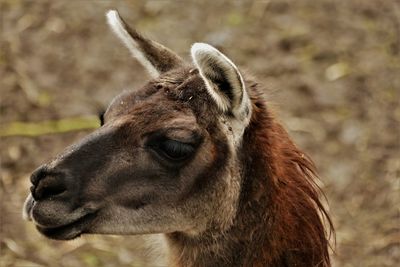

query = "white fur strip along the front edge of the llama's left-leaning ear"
[106,10,159,78]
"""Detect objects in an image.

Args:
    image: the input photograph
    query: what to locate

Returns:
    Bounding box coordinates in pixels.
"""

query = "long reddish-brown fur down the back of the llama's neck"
[244,82,332,266]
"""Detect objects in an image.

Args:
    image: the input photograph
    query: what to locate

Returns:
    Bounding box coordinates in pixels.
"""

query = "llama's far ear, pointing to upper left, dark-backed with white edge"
[107,10,183,78]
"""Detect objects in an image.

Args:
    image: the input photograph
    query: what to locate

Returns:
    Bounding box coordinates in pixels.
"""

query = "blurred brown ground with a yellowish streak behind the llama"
[0,0,400,267]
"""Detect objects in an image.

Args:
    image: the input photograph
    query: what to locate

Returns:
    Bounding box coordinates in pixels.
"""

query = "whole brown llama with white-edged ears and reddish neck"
[23,10,332,267]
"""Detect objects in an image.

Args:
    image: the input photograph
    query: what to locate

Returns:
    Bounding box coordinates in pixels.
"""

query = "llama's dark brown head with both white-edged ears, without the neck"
[24,11,252,239]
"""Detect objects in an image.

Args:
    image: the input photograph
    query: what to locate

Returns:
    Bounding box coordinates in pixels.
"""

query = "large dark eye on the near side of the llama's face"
[157,139,195,161]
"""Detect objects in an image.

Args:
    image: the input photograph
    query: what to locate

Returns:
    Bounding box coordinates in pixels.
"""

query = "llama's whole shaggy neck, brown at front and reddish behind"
[167,84,333,267]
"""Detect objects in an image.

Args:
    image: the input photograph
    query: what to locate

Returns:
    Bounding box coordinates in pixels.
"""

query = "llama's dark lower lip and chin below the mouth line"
[36,213,96,240]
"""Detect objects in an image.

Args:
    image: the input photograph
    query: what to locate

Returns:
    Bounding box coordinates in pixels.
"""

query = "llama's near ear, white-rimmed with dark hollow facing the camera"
[191,43,250,118]
